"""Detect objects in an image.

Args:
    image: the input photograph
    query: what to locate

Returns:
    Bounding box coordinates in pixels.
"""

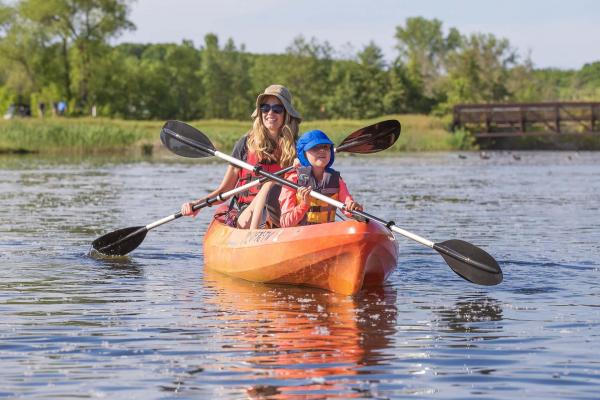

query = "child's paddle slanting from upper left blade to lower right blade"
[160,121,503,285]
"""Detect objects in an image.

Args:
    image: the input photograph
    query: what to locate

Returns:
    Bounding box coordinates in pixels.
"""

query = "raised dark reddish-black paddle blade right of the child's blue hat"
[335,119,400,154]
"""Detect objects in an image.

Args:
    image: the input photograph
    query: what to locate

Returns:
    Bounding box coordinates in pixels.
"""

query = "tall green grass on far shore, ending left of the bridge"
[0,115,456,154]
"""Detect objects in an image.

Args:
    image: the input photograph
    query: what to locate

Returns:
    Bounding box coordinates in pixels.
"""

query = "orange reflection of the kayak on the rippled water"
[203,270,397,399]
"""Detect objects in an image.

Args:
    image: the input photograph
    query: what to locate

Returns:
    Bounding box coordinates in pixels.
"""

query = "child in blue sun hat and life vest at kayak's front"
[279,130,362,228]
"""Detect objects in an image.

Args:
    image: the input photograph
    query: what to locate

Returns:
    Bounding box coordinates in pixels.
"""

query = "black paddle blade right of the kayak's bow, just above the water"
[433,239,503,286]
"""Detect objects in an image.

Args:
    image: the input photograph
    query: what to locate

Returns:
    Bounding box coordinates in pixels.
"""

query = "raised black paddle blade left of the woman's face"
[160,120,215,158]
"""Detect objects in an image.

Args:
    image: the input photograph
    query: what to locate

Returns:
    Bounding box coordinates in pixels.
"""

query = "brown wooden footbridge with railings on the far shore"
[453,102,600,139]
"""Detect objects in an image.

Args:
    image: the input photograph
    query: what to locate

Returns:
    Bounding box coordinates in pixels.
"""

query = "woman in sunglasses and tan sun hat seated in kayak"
[181,85,302,229]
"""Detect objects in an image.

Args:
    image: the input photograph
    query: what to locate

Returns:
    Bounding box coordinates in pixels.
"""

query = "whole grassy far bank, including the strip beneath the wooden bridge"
[0,114,600,156]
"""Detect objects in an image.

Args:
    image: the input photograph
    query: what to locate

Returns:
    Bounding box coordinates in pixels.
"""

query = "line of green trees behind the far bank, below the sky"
[0,0,600,120]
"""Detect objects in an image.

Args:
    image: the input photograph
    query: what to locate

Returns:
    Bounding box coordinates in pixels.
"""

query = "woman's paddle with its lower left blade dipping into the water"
[92,120,400,256]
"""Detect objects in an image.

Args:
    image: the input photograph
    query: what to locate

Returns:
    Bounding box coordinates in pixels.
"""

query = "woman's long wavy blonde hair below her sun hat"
[247,110,300,168]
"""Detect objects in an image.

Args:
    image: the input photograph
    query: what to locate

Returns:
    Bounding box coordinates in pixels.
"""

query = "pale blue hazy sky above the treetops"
[115,0,600,69]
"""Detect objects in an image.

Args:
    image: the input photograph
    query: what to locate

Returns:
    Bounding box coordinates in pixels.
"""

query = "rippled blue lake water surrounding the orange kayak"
[0,152,600,399]
